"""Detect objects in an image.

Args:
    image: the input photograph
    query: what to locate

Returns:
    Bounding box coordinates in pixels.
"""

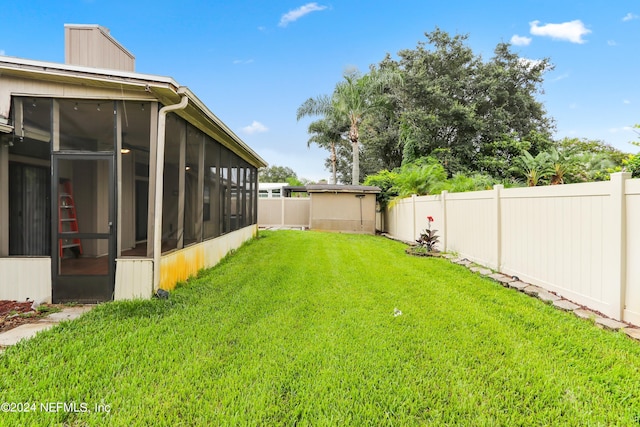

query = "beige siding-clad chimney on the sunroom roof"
[64,24,136,72]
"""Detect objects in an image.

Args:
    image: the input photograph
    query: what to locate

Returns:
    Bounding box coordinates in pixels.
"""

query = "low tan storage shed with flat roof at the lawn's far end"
[307,184,380,234]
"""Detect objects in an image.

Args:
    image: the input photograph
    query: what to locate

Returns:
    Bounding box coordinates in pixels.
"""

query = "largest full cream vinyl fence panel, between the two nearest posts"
[500,182,613,312]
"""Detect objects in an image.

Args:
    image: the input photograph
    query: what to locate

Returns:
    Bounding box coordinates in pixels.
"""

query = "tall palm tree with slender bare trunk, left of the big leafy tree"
[296,70,401,185]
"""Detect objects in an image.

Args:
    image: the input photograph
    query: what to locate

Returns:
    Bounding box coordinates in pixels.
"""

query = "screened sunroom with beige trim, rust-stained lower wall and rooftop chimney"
[0,26,266,303]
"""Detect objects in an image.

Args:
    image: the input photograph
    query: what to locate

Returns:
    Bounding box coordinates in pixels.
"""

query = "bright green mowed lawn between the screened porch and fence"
[0,231,640,426]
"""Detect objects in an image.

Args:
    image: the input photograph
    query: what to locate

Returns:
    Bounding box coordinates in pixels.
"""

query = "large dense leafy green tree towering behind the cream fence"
[380,29,552,178]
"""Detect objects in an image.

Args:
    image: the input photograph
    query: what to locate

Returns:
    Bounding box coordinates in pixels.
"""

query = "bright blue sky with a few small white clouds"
[0,0,640,180]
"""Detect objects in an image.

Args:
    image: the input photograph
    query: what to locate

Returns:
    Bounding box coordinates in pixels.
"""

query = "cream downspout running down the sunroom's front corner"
[153,92,189,292]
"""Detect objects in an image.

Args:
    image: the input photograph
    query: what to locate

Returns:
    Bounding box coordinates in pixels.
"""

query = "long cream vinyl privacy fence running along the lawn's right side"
[384,172,640,325]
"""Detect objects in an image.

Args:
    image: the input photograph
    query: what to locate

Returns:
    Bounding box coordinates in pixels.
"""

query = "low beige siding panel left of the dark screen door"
[0,257,51,302]
